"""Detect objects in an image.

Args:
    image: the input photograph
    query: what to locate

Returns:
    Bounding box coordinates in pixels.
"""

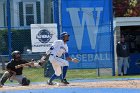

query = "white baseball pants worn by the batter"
[49,55,69,76]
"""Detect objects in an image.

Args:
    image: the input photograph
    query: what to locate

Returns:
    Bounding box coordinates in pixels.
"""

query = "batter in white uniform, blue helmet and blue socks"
[46,32,79,85]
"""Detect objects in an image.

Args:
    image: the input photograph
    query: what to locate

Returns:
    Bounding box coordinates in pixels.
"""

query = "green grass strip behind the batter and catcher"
[23,68,140,82]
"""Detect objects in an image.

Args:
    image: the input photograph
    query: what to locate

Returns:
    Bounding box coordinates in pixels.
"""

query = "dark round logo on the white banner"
[36,29,52,43]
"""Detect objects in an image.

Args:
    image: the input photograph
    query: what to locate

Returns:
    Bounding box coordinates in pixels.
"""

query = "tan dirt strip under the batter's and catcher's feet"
[0,80,140,91]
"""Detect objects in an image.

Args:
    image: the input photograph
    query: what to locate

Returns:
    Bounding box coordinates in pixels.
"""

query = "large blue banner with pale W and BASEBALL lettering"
[60,0,113,68]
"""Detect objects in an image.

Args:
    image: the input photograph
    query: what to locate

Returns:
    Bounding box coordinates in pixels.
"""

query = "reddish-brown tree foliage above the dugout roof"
[113,0,140,17]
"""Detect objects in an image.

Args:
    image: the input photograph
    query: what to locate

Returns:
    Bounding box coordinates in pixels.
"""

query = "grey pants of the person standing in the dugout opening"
[118,57,129,74]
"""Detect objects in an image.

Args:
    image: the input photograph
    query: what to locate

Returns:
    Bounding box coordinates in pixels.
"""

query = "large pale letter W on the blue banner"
[67,7,103,50]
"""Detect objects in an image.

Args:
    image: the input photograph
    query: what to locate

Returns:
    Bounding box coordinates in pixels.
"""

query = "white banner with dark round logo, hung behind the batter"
[31,24,57,52]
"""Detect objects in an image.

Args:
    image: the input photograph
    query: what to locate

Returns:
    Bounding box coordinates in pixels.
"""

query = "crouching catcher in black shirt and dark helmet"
[0,51,34,87]
